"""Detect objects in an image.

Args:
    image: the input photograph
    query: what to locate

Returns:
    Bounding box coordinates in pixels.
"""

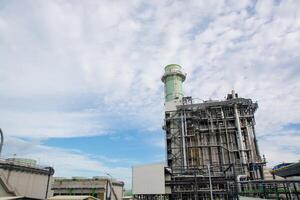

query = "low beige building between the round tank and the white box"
[52,177,124,200]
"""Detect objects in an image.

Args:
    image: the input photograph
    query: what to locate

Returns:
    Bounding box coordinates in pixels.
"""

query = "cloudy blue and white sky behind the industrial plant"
[0,0,300,188]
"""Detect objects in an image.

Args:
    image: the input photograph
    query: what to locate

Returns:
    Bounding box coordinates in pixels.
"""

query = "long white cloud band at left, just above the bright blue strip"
[0,111,110,139]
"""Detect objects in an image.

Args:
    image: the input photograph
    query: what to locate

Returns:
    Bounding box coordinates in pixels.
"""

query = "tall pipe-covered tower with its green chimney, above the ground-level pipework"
[162,65,264,179]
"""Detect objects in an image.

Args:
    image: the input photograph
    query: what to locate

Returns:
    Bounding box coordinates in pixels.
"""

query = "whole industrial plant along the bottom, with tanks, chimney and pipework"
[0,64,300,200]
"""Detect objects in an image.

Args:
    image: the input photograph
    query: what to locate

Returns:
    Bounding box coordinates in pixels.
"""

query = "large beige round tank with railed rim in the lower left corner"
[0,158,54,199]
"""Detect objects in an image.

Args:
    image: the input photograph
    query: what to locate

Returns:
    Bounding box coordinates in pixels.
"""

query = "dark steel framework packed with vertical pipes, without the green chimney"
[164,93,265,199]
